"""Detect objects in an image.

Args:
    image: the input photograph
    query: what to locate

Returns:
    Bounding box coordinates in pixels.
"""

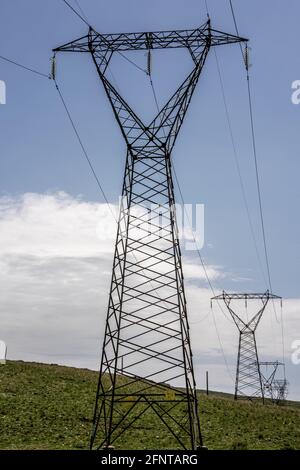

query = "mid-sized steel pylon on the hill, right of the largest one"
[212,291,281,401]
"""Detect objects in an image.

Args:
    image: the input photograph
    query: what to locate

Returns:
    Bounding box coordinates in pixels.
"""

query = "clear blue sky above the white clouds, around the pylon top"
[0,0,300,398]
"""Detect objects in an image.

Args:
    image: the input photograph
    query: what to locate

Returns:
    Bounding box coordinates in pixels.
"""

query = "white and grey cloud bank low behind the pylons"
[0,192,300,396]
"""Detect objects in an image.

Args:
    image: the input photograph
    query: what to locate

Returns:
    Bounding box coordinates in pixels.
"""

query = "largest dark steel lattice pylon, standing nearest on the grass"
[54,21,246,449]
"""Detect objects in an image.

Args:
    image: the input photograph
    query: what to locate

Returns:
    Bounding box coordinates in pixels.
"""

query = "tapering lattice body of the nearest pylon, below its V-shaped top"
[91,151,202,450]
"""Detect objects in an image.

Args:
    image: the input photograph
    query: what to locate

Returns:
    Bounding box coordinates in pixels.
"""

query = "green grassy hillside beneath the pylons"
[0,361,300,449]
